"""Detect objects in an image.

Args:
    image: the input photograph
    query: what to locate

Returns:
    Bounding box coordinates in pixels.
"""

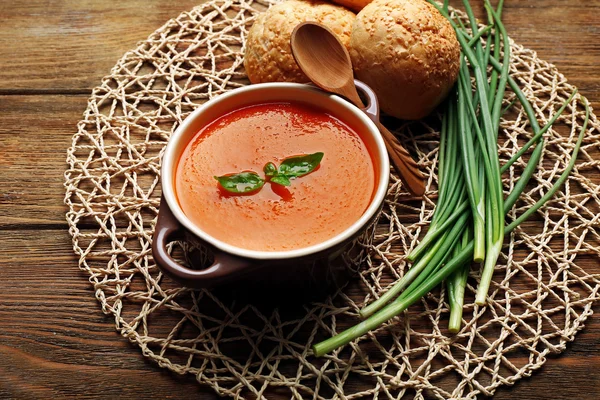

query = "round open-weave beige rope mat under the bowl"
[65,0,600,399]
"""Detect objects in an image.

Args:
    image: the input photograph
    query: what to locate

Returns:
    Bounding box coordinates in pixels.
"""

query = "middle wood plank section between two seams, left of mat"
[0,95,86,225]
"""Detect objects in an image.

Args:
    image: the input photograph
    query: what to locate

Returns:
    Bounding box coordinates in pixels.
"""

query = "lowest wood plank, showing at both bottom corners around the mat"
[0,229,600,399]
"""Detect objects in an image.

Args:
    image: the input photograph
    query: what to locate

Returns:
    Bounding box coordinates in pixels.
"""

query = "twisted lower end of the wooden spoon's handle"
[377,122,425,196]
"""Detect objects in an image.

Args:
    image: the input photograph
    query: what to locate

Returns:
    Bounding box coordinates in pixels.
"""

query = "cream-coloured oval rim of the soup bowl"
[161,82,390,260]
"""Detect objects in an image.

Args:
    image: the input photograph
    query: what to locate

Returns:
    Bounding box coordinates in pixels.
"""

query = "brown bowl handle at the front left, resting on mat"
[152,197,254,288]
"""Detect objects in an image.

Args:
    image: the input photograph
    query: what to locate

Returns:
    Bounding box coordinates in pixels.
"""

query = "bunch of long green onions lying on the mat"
[313,0,590,356]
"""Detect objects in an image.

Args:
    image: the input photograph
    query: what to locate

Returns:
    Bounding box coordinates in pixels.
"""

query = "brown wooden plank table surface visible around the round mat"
[0,0,600,399]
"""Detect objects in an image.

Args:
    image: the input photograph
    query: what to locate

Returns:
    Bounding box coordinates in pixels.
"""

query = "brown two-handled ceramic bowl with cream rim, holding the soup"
[152,81,390,289]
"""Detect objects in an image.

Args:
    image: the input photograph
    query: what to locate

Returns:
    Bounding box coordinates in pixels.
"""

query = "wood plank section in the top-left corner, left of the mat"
[0,0,201,93]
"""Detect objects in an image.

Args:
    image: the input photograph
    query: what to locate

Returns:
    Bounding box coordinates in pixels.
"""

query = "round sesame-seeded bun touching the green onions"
[350,0,460,119]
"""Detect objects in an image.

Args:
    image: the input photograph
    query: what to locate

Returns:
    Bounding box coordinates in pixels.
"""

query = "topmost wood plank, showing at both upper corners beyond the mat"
[0,0,600,97]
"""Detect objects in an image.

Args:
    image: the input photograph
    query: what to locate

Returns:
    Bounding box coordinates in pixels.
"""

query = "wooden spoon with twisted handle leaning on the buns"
[290,22,425,196]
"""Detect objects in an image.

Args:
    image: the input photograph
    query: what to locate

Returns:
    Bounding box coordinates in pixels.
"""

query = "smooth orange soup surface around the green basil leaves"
[175,103,375,251]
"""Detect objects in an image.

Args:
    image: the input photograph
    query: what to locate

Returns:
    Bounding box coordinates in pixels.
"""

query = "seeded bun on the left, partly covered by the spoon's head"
[244,0,356,83]
